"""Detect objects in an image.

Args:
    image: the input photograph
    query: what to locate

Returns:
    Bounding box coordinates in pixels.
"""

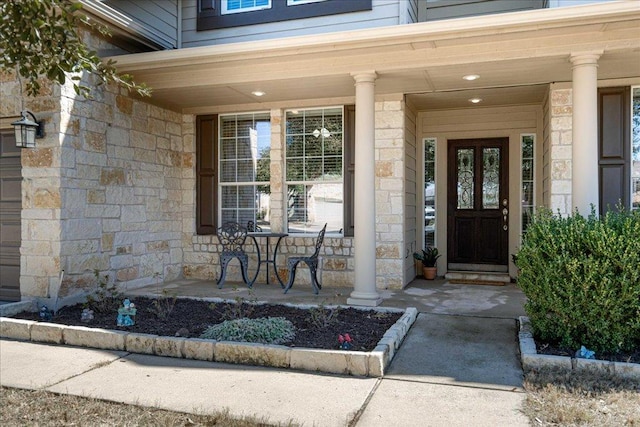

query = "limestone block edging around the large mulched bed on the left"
[0,298,418,377]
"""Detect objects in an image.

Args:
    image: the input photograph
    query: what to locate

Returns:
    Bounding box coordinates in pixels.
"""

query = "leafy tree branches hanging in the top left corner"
[0,0,151,96]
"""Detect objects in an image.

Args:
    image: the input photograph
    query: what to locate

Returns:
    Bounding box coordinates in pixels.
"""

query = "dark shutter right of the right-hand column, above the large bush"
[596,87,631,215]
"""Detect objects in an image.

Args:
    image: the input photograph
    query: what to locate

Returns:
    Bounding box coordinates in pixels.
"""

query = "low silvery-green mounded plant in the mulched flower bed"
[200,317,296,344]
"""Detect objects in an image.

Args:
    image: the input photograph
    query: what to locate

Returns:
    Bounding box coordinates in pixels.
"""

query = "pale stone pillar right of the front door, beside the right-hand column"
[545,84,573,215]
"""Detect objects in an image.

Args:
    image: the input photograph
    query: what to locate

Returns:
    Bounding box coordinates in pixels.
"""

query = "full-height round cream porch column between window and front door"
[347,71,382,306]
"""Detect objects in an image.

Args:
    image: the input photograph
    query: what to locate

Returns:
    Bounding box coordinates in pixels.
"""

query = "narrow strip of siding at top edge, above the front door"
[419,0,544,22]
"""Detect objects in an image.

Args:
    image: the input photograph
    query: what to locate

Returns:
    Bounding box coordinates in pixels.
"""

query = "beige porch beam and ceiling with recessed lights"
[113,2,640,113]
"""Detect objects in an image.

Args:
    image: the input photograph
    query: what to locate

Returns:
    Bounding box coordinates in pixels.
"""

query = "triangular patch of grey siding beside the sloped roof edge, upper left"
[104,0,178,47]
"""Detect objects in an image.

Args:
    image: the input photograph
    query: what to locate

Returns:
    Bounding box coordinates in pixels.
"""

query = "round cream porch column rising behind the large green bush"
[571,52,602,215]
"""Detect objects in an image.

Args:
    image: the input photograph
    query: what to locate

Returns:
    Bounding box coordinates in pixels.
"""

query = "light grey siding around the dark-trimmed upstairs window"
[182,0,400,48]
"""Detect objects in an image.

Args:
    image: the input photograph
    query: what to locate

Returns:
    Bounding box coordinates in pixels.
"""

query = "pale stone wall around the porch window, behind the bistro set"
[183,97,405,288]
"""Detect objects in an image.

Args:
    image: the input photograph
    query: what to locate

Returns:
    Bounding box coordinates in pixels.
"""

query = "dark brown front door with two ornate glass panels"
[447,138,509,271]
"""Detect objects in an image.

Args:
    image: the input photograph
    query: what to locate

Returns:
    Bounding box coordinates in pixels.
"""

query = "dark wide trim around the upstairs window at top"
[196,0,373,31]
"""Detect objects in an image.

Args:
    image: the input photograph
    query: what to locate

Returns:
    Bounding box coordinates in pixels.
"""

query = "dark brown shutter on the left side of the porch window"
[196,115,218,234]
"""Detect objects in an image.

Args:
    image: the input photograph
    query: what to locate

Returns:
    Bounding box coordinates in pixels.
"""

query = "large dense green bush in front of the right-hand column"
[515,210,640,354]
